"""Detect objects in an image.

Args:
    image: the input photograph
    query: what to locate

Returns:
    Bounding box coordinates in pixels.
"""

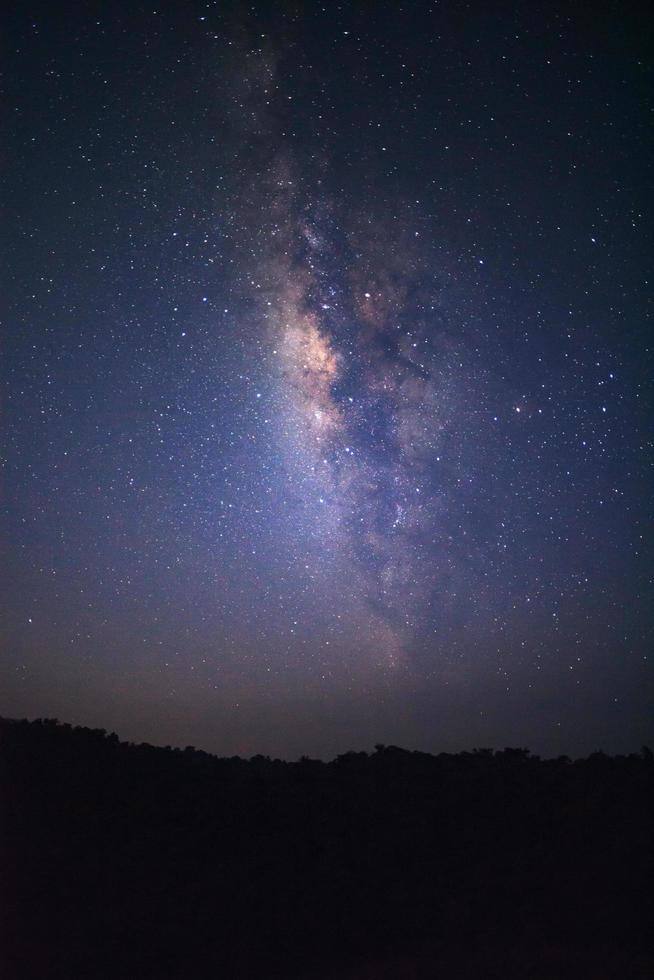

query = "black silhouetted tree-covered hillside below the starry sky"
[0,721,654,980]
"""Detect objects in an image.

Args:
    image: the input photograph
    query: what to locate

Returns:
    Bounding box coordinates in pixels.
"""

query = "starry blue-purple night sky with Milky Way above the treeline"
[0,0,654,758]
